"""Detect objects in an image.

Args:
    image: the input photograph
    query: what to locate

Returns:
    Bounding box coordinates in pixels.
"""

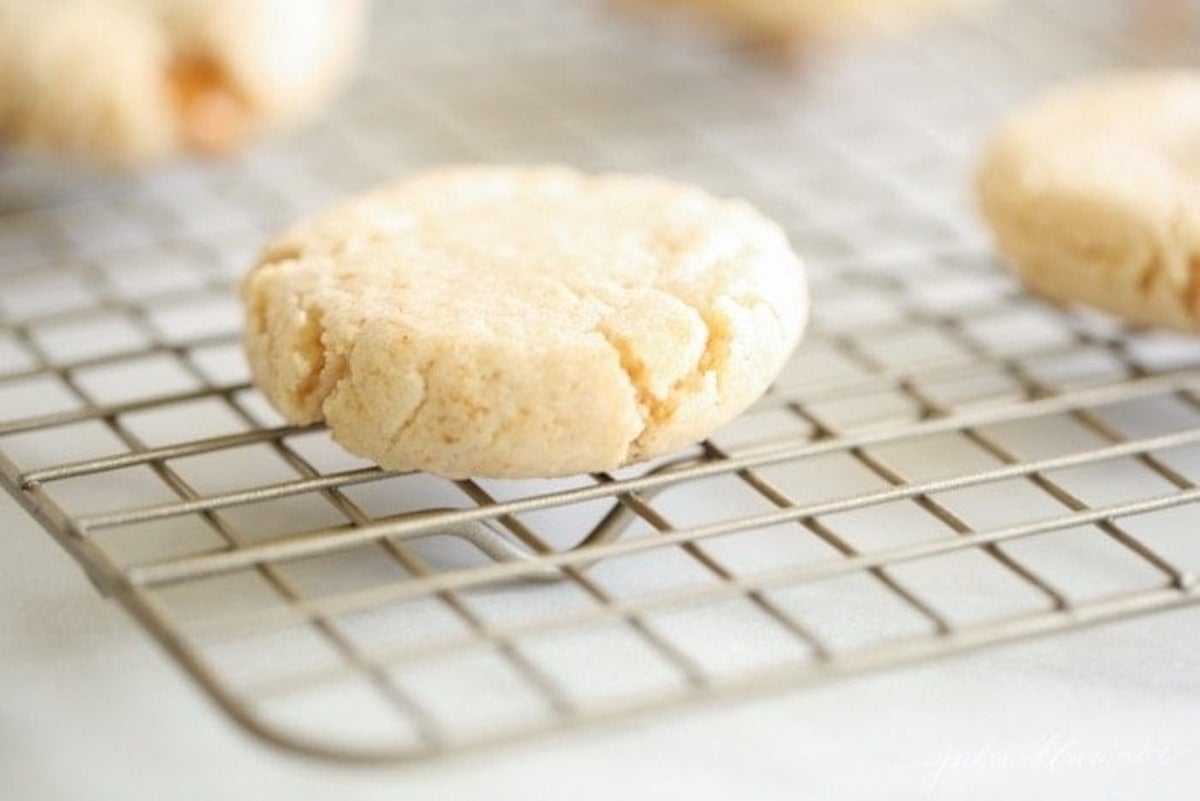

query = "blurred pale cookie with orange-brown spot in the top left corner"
[0,0,364,163]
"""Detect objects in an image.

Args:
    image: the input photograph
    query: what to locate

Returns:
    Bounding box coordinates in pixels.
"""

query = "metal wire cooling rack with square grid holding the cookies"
[0,0,1200,760]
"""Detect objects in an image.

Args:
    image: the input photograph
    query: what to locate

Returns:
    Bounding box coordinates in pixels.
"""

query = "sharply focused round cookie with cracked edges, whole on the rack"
[242,167,808,477]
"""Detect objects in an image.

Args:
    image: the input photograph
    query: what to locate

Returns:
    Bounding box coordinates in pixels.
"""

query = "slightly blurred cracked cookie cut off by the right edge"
[978,71,1200,331]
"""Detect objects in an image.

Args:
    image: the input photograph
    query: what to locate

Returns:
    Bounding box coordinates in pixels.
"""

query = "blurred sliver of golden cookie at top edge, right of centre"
[619,0,965,53]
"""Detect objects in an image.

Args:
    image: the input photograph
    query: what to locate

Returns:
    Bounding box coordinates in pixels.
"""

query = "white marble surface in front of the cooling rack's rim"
[0,496,1200,801]
